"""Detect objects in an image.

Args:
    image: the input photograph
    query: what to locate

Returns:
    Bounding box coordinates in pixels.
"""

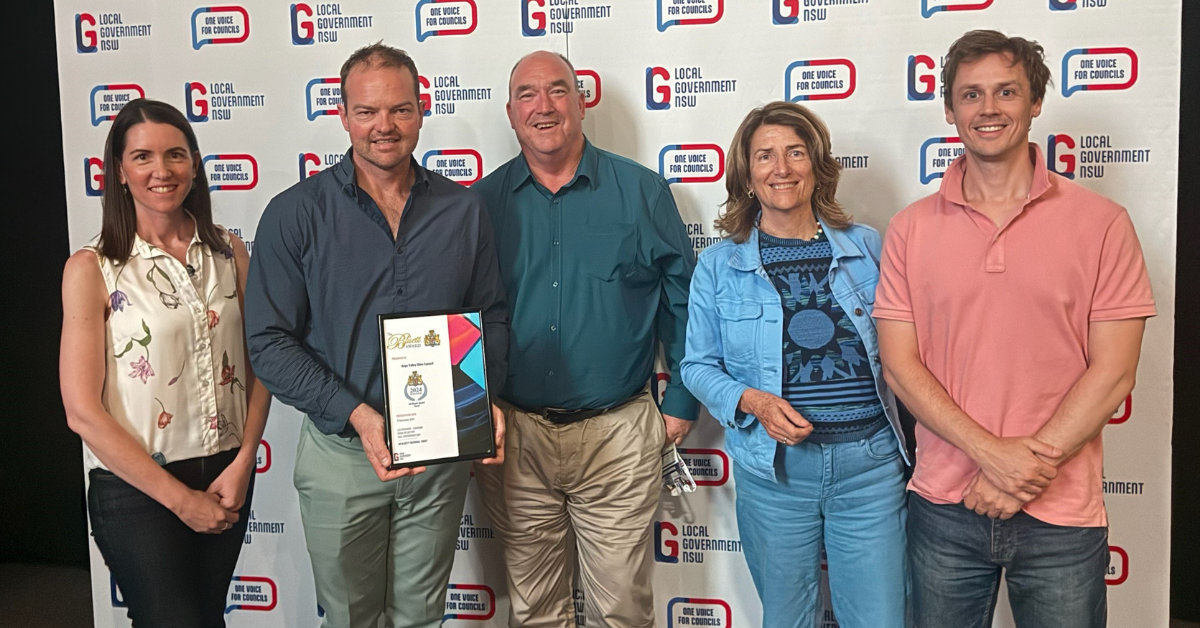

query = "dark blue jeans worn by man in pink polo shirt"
[908,494,1109,628]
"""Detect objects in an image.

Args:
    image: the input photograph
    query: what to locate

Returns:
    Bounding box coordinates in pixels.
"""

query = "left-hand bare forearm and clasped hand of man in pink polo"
[876,319,1060,502]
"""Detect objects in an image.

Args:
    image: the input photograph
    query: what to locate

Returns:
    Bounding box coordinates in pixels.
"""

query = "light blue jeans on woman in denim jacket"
[733,427,907,628]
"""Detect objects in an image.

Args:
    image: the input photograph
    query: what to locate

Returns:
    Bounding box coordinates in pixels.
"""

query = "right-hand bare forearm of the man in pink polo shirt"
[1037,318,1146,465]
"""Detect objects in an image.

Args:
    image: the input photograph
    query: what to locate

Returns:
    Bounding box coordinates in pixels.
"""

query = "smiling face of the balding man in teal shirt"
[505,52,584,162]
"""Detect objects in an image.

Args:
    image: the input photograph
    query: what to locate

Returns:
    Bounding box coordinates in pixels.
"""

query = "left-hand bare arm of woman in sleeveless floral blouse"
[59,251,238,532]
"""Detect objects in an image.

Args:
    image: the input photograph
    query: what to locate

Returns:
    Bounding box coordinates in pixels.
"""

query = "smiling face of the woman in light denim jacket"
[750,125,816,217]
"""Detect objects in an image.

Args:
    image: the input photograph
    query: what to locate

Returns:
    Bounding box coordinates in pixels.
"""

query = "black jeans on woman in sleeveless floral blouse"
[88,449,254,628]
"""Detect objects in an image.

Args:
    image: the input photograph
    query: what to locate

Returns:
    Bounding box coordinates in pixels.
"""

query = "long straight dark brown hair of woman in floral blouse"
[97,98,229,264]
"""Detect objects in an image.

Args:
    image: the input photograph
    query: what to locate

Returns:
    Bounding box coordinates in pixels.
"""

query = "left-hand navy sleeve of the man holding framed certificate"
[245,192,362,433]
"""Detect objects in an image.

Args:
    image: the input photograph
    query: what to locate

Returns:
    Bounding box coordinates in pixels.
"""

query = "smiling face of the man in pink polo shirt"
[946,53,1042,161]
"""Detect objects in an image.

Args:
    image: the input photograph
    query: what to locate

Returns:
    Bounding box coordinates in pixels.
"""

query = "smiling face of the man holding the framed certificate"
[337,61,424,171]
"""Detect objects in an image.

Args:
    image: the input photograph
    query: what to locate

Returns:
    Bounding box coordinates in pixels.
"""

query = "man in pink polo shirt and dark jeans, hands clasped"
[875,31,1154,628]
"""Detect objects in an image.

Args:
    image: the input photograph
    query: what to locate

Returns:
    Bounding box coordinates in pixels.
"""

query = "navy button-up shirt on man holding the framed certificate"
[245,152,508,433]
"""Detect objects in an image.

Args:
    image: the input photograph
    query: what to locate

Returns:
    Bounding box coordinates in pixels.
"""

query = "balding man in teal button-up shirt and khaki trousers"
[474,52,697,628]
